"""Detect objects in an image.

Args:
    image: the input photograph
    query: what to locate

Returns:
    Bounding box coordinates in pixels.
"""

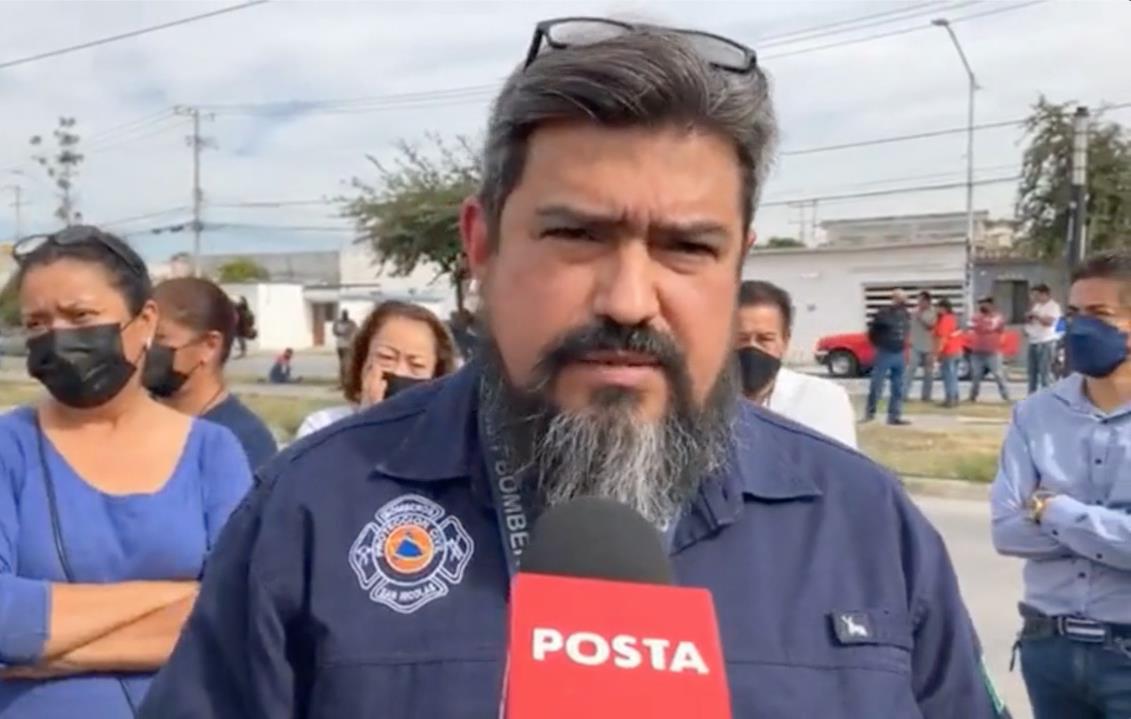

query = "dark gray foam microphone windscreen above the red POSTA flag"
[519,497,675,584]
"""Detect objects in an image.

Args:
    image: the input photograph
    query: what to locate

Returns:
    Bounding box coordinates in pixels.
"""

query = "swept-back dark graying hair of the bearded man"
[480,27,777,237]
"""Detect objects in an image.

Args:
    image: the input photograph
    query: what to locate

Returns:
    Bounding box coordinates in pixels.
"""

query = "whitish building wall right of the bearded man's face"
[742,242,965,364]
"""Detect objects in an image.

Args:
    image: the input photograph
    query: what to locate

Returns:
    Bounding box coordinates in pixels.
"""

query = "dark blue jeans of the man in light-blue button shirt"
[1021,636,1131,719]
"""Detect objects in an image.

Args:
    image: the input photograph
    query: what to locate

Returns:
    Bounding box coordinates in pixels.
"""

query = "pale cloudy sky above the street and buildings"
[0,0,1131,261]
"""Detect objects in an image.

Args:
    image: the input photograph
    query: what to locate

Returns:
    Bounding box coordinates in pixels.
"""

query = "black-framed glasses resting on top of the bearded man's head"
[524,17,758,75]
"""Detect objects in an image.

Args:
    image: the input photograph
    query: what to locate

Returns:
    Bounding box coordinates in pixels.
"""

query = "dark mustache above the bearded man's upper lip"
[534,319,688,384]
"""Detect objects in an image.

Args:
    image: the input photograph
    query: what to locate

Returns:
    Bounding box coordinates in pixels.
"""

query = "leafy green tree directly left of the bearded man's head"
[339,135,481,309]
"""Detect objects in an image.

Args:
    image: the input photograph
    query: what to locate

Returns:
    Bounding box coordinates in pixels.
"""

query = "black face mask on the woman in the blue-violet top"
[27,324,137,409]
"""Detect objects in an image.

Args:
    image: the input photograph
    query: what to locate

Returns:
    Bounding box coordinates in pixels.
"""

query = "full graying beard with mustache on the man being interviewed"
[480,321,739,528]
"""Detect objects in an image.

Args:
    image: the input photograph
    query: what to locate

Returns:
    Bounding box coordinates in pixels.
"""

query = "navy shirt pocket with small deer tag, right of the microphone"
[727,608,922,719]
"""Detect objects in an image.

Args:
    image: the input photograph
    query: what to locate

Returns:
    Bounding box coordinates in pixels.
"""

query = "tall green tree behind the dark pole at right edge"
[1017,96,1131,259]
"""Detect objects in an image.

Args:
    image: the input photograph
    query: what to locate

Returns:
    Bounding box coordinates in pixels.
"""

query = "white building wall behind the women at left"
[223,283,313,352]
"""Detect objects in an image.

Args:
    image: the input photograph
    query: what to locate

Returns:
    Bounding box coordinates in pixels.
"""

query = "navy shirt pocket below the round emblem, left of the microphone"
[305,647,504,719]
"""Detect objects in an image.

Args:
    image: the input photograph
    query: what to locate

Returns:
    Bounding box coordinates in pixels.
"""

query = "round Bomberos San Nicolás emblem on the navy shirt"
[349,494,475,614]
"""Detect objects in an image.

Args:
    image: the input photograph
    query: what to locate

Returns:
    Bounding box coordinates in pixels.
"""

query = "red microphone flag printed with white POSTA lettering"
[503,572,731,719]
